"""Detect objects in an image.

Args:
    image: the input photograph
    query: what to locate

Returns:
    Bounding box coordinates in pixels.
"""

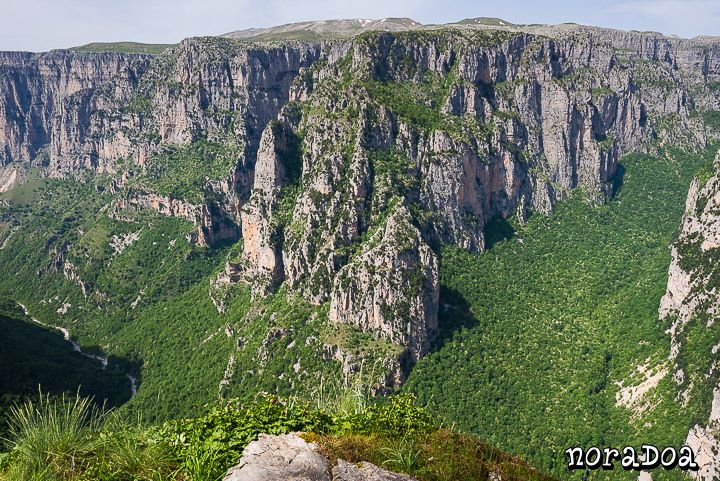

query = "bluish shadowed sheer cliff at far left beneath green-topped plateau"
[0,51,151,167]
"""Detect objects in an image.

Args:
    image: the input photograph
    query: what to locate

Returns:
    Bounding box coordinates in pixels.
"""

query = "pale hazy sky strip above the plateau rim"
[0,0,720,51]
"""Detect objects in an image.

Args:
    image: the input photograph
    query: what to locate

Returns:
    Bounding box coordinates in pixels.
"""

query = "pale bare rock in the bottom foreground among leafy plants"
[223,434,413,481]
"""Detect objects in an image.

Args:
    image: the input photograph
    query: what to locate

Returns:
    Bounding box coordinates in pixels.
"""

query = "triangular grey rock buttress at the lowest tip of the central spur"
[330,204,440,361]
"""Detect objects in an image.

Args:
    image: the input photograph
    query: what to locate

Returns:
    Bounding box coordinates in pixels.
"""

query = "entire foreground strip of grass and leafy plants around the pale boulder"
[0,395,549,481]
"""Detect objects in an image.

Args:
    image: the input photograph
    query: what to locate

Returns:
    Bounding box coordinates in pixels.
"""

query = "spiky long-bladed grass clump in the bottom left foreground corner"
[0,395,172,481]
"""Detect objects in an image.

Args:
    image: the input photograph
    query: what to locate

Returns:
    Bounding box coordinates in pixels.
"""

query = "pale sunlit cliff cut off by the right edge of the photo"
[659,152,720,481]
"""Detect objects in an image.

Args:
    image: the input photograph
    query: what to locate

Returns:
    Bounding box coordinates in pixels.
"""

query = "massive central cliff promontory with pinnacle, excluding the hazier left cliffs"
[235,27,705,360]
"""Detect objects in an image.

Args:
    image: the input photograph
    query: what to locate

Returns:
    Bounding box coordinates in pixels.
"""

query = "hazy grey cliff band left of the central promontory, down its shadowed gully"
[0,38,319,244]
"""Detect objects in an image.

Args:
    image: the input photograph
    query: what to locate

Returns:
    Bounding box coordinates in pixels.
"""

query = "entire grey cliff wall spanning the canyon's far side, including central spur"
[0,21,720,372]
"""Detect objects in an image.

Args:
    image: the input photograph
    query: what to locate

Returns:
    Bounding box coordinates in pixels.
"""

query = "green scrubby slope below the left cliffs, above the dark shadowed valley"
[0,178,358,421]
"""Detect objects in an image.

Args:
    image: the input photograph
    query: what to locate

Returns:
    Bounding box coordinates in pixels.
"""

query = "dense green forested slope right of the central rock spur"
[407,145,715,478]
